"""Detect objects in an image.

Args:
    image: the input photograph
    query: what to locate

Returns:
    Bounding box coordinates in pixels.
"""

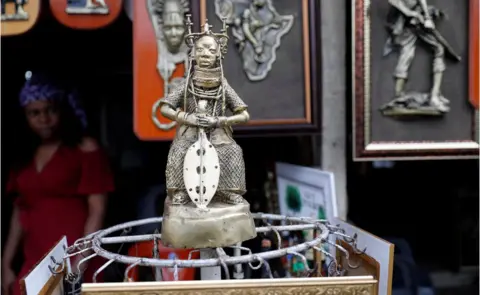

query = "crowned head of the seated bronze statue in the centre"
[185,15,228,69]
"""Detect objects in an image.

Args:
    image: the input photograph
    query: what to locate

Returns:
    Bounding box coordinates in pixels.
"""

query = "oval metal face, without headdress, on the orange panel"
[162,1,185,52]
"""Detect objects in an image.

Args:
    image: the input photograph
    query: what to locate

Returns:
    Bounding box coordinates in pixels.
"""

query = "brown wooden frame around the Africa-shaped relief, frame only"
[199,0,321,134]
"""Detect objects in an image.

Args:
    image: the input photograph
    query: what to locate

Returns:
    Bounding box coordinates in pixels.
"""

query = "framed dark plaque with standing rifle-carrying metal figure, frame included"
[352,0,480,161]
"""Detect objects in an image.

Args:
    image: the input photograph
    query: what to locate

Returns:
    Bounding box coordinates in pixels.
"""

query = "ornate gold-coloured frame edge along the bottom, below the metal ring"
[82,276,377,295]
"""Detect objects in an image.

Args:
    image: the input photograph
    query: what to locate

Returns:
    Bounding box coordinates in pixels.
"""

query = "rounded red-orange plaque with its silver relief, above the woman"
[50,0,123,30]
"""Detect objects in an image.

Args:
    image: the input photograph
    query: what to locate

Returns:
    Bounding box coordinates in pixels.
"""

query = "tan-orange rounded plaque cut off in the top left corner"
[1,0,40,36]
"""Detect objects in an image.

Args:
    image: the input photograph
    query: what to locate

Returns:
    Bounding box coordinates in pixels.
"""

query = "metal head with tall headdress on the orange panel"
[154,0,189,52]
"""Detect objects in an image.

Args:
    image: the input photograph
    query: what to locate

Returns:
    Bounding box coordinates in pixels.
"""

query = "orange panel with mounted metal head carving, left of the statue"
[133,0,190,140]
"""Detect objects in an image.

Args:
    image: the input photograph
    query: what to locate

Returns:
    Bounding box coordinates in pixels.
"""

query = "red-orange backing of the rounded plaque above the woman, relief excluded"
[50,0,123,30]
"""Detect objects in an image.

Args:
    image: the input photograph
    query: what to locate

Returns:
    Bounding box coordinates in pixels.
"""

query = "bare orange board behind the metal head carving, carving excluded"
[133,0,185,140]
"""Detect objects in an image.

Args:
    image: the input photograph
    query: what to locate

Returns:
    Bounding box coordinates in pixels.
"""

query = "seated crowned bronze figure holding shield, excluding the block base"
[160,17,249,207]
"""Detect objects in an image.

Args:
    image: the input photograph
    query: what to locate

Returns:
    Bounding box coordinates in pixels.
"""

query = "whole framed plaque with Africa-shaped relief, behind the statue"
[199,0,320,132]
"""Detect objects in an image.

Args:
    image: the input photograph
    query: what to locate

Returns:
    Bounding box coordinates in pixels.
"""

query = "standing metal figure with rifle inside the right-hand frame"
[381,0,461,116]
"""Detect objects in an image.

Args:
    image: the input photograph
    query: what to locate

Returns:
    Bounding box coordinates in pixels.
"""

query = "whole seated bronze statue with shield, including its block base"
[160,17,255,248]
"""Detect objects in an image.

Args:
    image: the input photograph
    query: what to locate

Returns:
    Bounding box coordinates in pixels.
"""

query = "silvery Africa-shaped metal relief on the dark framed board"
[215,0,294,81]
